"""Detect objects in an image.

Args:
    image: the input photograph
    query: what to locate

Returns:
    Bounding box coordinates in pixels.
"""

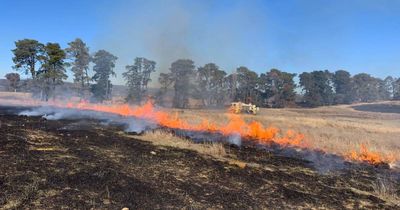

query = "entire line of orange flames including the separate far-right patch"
[3,97,397,165]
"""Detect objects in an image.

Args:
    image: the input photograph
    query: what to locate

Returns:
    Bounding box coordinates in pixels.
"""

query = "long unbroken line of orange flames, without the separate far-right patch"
[56,102,306,147]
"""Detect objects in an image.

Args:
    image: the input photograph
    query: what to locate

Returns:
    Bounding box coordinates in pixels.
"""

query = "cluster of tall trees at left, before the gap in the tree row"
[12,39,112,101]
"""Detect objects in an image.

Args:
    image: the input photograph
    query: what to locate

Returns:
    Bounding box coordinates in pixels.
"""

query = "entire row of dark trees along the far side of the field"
[6,38,400,108]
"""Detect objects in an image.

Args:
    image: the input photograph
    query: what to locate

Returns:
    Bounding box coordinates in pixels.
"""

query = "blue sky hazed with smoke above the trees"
[0,0,400,83]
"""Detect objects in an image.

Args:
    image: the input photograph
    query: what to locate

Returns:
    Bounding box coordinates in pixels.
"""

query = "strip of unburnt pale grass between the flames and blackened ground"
[135,130,227,159]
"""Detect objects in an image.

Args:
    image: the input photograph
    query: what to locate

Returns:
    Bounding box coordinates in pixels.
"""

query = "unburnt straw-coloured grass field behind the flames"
[169,102,400,159]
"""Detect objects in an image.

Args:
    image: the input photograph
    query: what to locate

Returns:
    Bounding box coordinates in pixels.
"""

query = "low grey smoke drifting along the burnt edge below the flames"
[19,106,400,174]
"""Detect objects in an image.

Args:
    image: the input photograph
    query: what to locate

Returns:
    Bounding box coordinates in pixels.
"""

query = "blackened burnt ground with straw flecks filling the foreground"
[0,107,400,209]
